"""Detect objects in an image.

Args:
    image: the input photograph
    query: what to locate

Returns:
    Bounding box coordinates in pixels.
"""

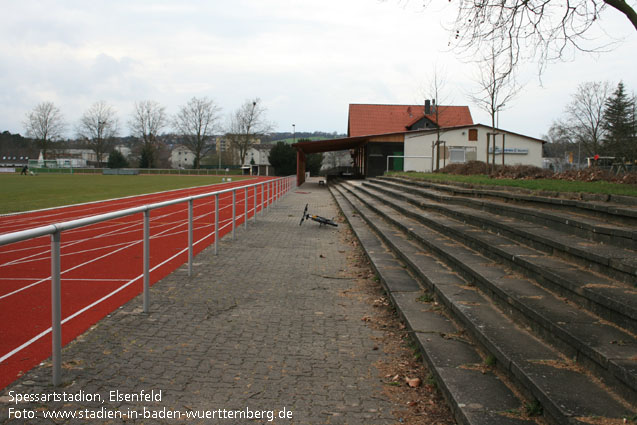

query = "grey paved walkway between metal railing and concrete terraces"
[0,181,396,425]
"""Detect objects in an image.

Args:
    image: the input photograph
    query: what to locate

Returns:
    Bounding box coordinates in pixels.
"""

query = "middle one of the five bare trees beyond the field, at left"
[129,100,167,168]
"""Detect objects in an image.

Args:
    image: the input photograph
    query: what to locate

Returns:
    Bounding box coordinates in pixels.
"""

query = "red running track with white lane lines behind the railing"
[0,178,280,389]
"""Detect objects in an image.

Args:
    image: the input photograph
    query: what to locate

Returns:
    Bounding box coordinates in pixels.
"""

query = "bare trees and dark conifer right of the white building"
[546,81,637,162]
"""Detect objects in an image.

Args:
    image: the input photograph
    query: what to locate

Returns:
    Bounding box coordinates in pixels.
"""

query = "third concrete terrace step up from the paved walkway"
[345,184,637,401]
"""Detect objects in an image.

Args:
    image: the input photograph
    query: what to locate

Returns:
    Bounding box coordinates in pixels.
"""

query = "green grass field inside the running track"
[0,174,252,214]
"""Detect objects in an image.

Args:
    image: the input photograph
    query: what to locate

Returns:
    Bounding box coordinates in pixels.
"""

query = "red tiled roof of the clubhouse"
[347,104,473,137]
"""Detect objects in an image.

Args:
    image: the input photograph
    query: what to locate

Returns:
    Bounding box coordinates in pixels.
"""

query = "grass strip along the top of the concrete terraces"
[388,172,637,197]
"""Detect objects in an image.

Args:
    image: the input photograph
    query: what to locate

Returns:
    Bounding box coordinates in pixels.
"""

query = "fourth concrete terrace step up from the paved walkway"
[360,179,637,333]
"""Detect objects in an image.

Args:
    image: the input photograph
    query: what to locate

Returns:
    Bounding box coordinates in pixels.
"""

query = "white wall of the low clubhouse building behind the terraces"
[404,125,542,172]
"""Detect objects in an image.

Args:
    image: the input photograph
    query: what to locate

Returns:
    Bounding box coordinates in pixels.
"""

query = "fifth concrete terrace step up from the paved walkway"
[365,178,637,284]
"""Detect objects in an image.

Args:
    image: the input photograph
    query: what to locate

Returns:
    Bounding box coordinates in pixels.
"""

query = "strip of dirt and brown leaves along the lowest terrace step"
[341,224,456,425]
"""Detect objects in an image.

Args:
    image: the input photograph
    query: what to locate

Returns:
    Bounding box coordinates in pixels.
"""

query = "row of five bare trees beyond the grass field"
[24,97,273,168]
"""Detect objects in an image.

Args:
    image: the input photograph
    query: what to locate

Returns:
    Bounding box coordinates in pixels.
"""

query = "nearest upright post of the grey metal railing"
[51,231,62,387]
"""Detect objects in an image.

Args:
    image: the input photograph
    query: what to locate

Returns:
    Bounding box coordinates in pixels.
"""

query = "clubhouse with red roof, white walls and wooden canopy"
[293,101,543,184]
